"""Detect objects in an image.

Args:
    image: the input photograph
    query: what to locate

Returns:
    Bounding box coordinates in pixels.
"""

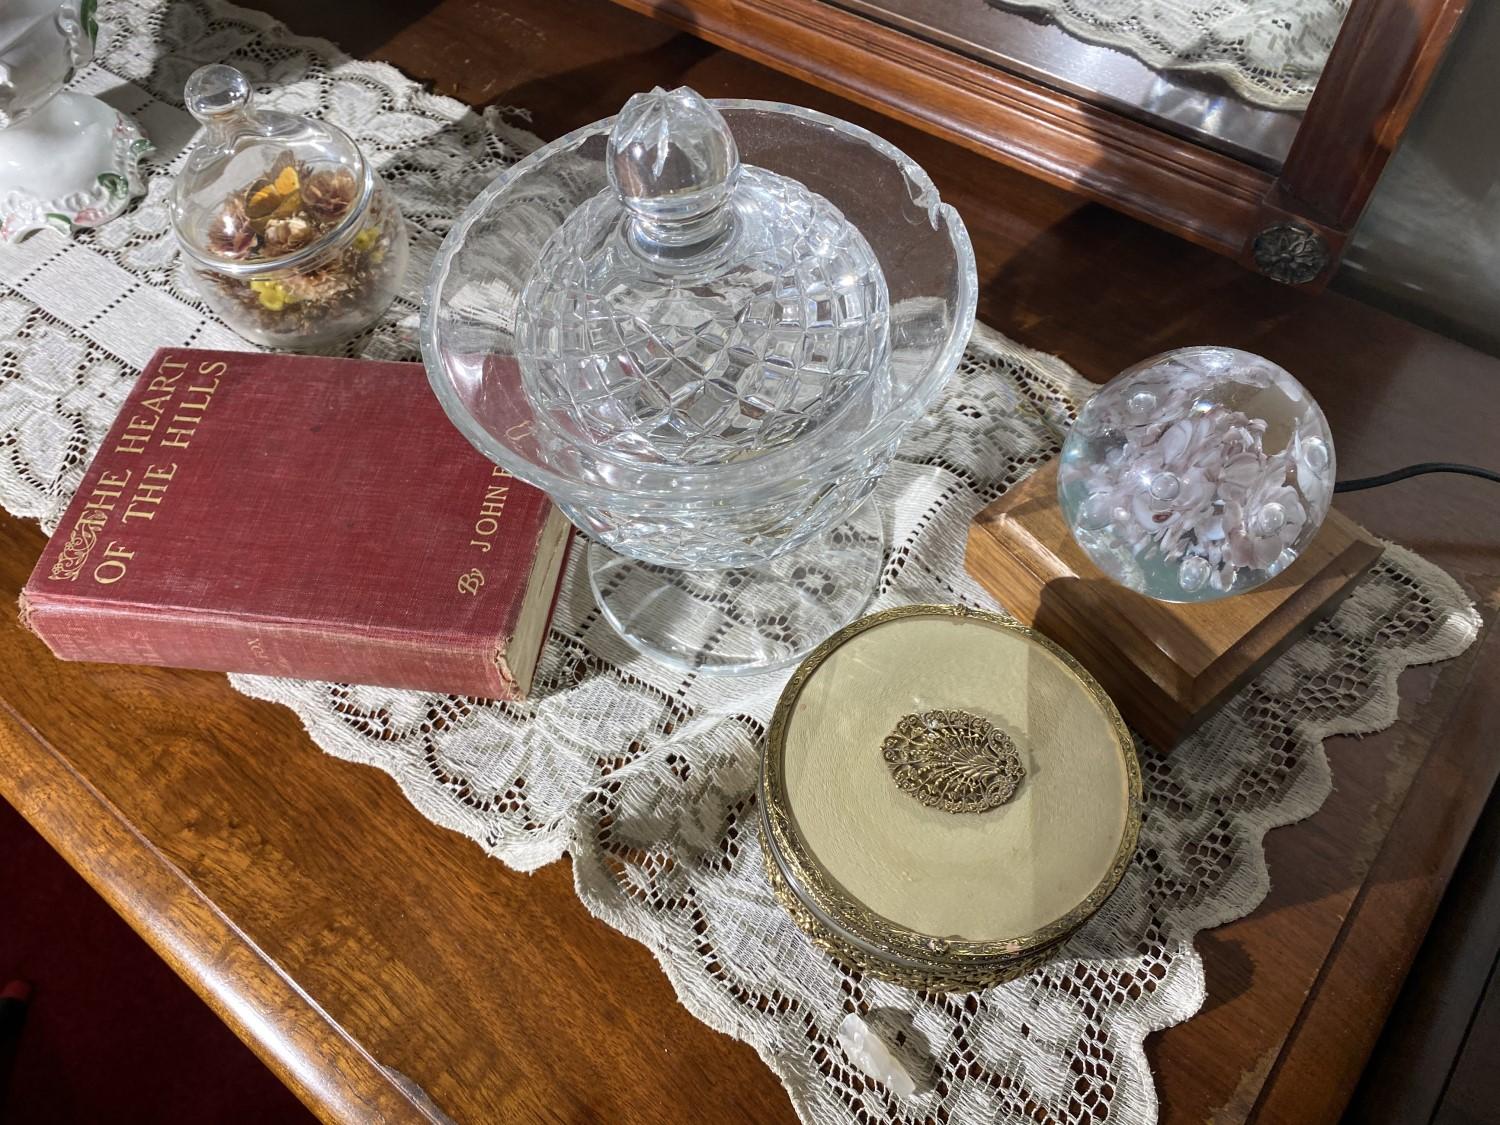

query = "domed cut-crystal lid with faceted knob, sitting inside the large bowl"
[516,87,890,468]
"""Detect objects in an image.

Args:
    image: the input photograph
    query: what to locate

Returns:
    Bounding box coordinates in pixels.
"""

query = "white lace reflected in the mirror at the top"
[990,0,1349,110]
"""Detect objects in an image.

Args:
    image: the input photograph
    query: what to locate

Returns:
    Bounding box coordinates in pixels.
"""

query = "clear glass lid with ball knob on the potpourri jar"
[173,65,374,272]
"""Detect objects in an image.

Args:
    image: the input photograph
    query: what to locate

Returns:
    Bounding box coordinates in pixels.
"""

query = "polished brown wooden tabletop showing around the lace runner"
[0,0,1500,1124]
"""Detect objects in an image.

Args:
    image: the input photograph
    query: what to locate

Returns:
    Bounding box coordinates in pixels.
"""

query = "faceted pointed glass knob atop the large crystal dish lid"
[606,86,740,255]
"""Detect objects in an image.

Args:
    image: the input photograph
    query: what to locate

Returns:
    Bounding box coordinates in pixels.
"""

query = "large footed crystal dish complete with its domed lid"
[422,89,977,671]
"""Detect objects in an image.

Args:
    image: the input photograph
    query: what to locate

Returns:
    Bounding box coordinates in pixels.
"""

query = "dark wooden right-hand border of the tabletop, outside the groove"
[1251,629,1500,1122]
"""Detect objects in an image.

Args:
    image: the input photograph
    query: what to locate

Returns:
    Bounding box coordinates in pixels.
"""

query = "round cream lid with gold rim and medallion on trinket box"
[762,606,1140,956]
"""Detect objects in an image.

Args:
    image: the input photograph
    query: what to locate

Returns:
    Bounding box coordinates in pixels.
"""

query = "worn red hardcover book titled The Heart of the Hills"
[21,348,569,699]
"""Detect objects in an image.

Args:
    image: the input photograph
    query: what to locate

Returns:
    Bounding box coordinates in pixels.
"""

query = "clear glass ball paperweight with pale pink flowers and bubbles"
[1058,347,1334,602]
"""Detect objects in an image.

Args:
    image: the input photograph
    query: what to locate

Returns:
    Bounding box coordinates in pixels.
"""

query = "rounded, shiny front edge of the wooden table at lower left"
[0,701,443,1124]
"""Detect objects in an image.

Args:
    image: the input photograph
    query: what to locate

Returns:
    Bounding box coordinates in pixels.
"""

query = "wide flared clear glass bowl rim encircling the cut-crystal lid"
[422,92,978,507]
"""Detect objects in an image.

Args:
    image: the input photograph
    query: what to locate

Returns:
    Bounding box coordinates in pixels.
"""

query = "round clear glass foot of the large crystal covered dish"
[588,501,885,675]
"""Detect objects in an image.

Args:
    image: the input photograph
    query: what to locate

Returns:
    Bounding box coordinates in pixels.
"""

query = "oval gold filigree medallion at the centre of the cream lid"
[881,711,1026,813]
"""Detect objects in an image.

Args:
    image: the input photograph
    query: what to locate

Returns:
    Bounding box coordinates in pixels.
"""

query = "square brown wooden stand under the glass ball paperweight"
[966,462,1382,750]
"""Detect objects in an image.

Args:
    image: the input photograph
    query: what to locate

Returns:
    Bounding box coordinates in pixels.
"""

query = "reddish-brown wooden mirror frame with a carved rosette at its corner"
[617,0,1469,288]
